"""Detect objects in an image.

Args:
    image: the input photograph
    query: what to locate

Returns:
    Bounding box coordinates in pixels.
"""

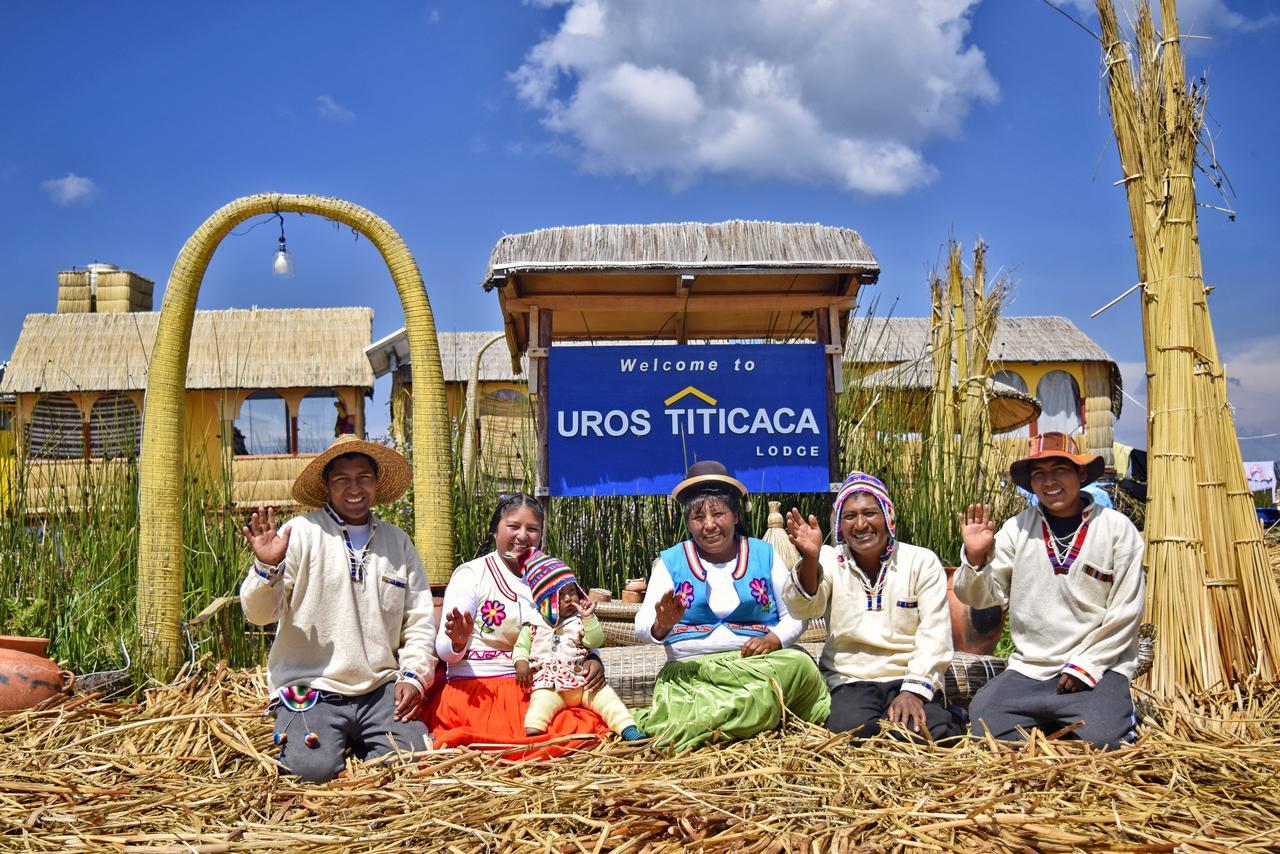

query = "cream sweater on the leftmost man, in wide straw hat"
[239,508,435,697]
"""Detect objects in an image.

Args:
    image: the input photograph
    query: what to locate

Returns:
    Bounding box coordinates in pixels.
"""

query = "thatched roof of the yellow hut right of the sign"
[845,316,1124,416]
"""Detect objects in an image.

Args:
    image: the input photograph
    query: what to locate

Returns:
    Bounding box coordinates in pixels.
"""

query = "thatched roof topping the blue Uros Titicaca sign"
[484,219,879,289]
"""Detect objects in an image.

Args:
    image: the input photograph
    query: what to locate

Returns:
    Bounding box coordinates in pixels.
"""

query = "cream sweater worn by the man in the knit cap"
[782,543,952,700]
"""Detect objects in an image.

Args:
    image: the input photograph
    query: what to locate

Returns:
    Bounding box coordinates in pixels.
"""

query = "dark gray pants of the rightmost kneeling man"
[969,670,1135,748]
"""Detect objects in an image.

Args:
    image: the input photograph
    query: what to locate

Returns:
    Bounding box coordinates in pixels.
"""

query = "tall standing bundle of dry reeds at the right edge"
[1097,0,1280,697]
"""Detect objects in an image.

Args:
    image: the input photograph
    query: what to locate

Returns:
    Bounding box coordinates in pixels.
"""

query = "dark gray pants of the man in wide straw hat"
[274,682,428,782]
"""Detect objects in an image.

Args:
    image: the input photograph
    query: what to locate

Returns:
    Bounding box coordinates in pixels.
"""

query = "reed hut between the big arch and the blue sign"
[365,328,538,488]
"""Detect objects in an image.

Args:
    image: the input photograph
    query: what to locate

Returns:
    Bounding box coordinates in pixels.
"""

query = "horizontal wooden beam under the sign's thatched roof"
[503,293,852,314]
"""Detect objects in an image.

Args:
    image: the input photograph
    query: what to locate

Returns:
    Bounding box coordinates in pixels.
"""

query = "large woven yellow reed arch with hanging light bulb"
[137,193,453,675]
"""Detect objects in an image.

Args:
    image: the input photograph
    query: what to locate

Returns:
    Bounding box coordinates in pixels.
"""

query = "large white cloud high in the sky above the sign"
[511,0,998,195]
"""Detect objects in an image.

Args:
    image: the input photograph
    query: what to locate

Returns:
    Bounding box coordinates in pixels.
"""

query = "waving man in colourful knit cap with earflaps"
[782,471,961,740]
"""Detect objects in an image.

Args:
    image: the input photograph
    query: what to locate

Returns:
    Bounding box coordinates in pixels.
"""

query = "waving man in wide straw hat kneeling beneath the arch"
[241,435,435,782]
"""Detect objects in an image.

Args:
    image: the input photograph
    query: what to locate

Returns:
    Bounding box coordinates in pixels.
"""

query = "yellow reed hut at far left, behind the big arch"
[0,286,374,513]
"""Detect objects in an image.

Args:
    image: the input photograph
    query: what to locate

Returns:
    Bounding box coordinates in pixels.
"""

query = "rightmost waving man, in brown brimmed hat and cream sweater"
[954,433,1146,748]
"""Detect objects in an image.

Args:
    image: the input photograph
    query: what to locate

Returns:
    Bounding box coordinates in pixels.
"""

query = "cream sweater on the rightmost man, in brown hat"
[952,503,1146,686]
